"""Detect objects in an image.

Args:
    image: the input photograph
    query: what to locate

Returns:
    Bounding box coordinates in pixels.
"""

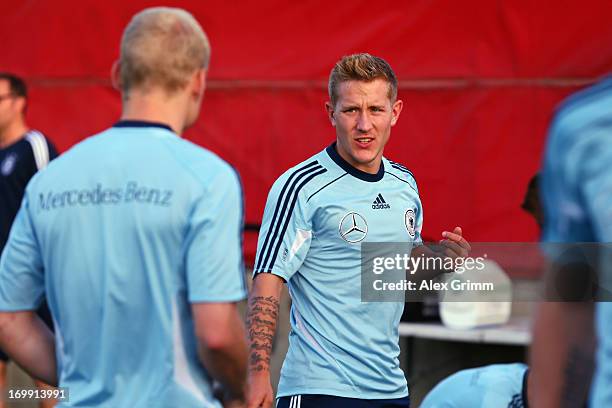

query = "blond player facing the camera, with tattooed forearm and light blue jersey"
[247,54,469,408]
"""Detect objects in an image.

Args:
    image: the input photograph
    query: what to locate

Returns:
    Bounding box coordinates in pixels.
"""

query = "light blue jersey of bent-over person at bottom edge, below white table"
[421,363,527,408]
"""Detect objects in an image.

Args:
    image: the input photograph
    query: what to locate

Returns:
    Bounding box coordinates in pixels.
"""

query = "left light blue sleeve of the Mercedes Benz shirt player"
[0,195,45,311]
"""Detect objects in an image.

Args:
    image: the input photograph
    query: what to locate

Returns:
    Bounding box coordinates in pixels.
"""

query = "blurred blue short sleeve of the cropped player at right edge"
[542,99,612,299]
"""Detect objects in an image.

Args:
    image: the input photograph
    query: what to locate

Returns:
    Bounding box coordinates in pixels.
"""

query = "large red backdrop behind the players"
[0,0,612,268]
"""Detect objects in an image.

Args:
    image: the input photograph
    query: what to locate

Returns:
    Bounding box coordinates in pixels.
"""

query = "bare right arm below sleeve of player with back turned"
[191,303,247,402]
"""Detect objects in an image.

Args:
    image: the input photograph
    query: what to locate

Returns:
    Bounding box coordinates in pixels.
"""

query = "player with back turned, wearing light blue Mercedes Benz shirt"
[0,7,247,407]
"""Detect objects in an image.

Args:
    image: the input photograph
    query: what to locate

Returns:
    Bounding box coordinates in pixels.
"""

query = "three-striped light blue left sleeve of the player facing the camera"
[253,173,312,281]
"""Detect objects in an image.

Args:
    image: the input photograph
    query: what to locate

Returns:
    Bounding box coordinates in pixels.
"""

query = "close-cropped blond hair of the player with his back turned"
[119,7,210,93]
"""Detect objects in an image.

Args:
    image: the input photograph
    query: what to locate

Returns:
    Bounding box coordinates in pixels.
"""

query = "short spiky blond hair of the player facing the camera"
[327,53,397,105]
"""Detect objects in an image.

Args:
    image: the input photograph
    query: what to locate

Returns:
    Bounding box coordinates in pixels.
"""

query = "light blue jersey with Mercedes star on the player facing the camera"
[254,145,423,399]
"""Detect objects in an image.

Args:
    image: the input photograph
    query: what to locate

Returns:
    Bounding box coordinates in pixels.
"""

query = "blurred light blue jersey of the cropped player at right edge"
[542,79,612,407]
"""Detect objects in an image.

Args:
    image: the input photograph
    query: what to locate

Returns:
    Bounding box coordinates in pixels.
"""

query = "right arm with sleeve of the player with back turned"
[185,166,247,406]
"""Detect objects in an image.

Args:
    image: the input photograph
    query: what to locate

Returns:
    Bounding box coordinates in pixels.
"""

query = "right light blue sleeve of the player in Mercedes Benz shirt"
[186,166,247,303]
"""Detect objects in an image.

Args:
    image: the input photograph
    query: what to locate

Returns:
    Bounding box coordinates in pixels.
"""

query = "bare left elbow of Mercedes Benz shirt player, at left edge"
[0,311,57,386]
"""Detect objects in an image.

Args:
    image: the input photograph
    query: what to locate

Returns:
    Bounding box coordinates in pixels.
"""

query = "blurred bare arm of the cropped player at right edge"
[529,302,595,408]
